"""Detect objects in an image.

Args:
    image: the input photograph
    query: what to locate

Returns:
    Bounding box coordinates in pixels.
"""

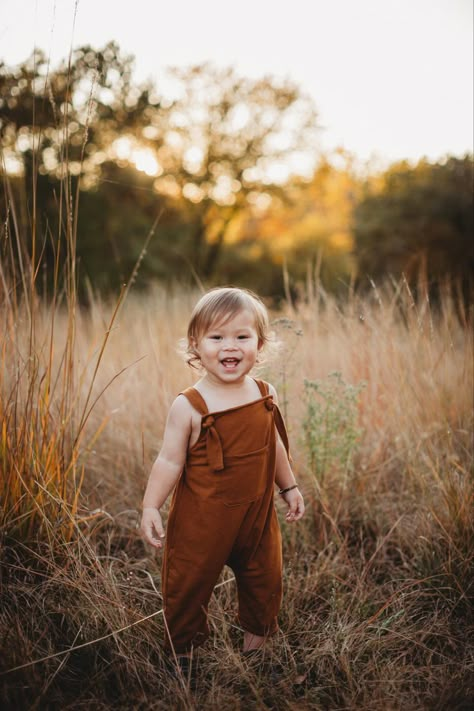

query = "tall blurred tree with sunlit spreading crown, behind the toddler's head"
[140,64,316,277]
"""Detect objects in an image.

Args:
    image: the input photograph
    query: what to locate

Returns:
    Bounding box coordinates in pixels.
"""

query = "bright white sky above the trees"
[0,0,474,163]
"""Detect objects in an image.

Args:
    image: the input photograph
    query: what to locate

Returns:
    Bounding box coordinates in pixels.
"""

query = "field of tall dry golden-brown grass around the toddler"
[0,282,474,711]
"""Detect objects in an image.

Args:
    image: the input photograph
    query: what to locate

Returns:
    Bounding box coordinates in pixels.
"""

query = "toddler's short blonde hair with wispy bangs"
[186,286,269,368]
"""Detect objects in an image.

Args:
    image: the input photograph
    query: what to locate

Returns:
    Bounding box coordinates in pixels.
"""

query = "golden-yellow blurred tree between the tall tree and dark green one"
[226,148,362,294]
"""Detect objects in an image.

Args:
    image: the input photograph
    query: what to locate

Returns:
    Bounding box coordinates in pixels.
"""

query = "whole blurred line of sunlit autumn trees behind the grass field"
[0,43,474,299]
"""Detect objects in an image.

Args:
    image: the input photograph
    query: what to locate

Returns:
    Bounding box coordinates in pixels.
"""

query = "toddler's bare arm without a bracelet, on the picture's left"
[140,395,192,548]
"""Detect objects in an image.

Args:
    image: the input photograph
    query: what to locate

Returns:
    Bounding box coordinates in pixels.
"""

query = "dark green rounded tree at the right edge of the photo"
[354,155,474,296]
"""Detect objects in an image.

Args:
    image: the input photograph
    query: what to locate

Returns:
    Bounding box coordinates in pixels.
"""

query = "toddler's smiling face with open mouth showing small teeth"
[195,310,263,384]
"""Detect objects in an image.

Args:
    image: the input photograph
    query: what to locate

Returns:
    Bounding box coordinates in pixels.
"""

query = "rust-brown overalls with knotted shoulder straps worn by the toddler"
[162,380,288,653]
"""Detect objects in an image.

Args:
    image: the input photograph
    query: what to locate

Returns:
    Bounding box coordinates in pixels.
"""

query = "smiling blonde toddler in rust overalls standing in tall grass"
[141,287,304,659]
